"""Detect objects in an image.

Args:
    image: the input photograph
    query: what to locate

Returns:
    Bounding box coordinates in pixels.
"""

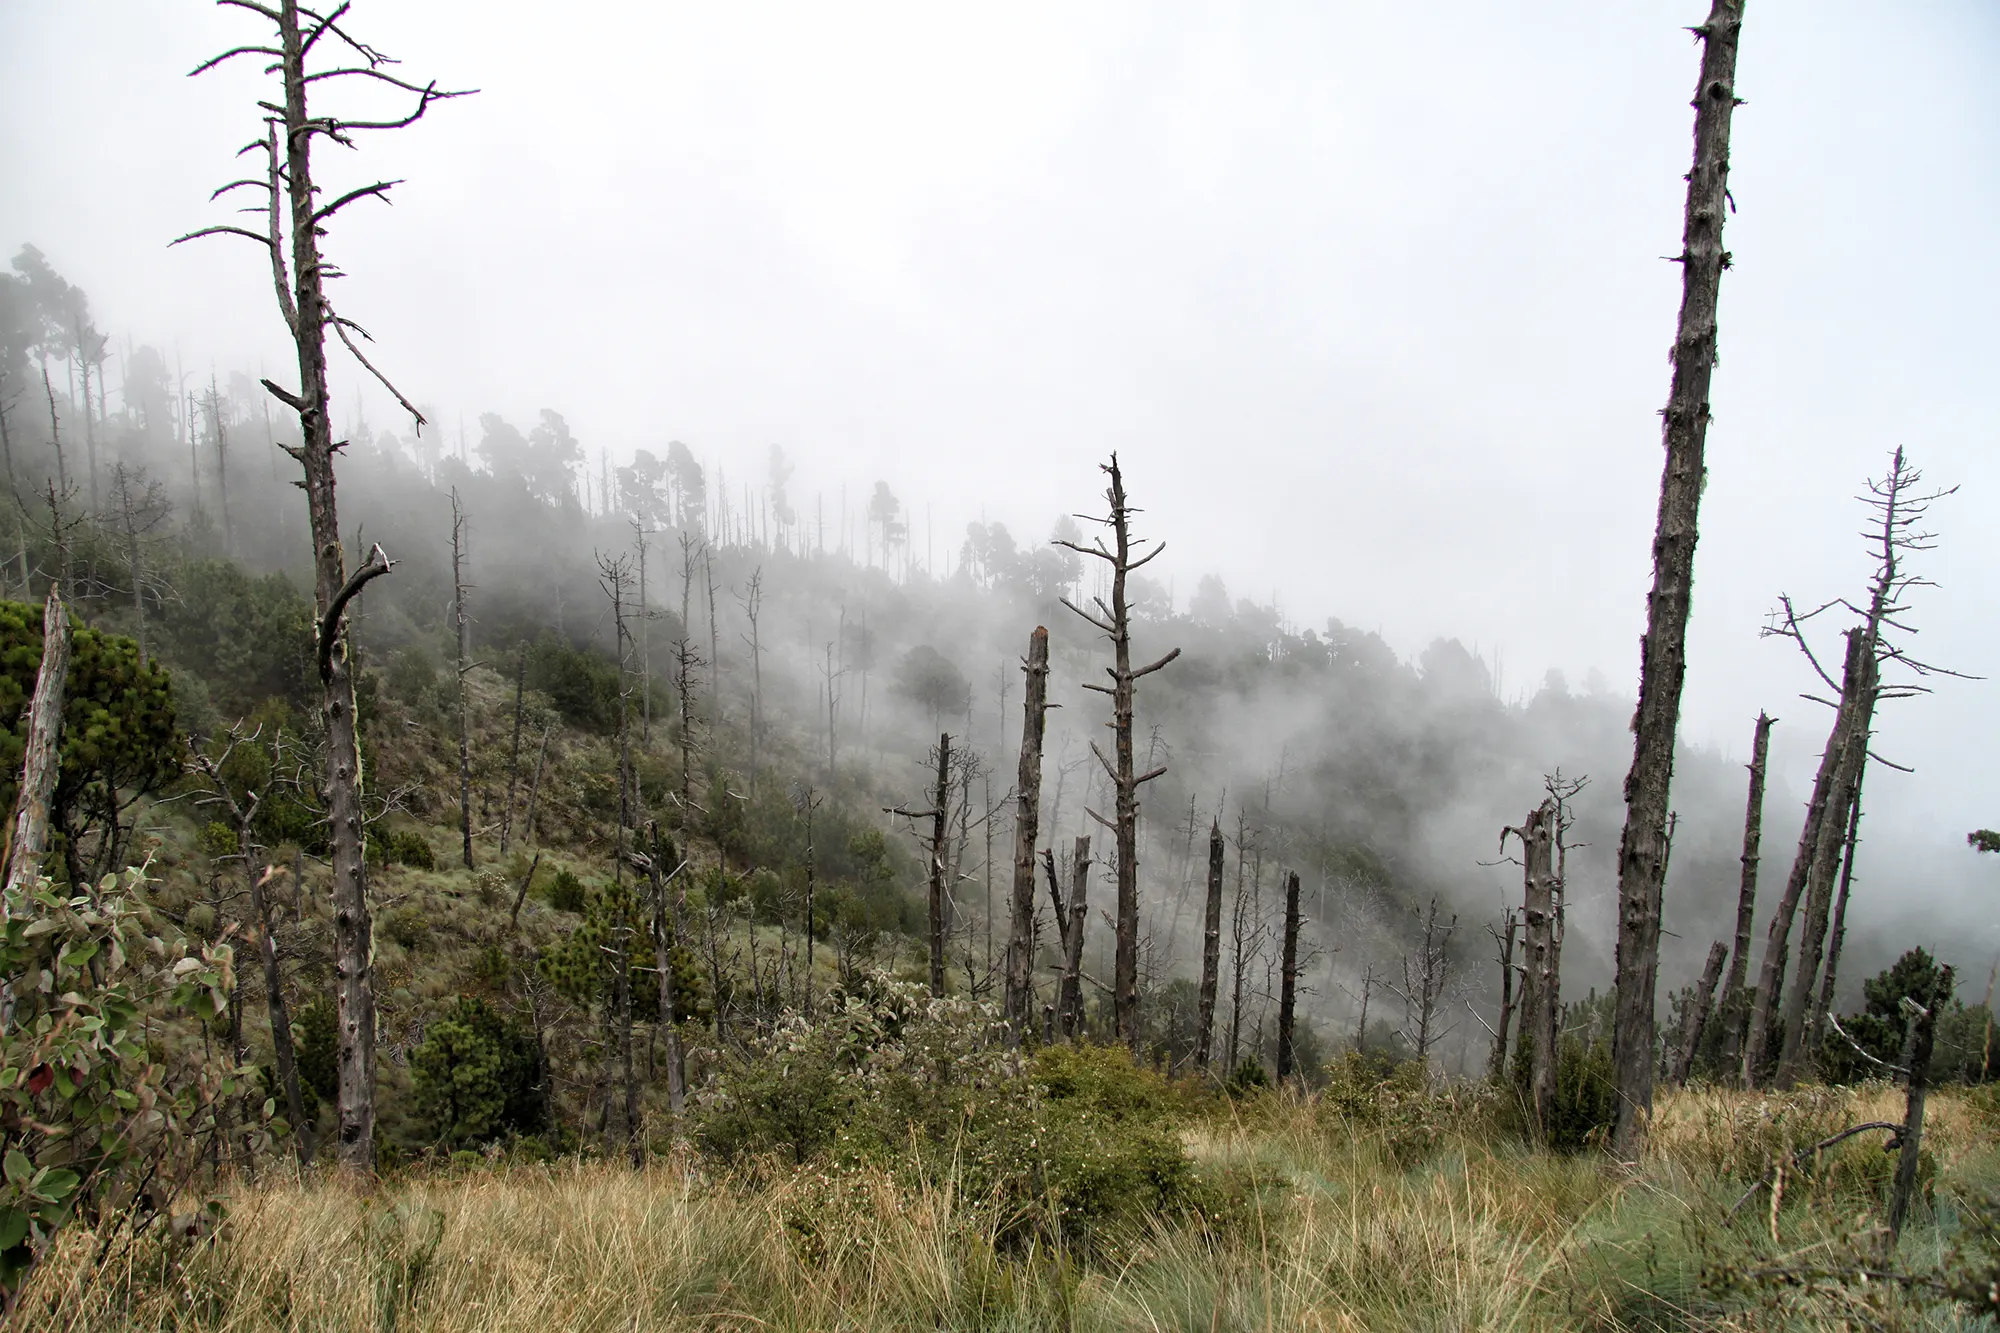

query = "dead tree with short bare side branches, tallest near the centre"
[1056,454,1180,1051]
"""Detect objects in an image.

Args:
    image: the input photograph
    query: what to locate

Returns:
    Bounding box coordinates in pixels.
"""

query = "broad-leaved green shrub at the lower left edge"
[0,869,242,1293]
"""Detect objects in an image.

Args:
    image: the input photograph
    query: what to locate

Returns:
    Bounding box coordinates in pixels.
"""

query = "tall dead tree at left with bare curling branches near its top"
[176,0,472,1171]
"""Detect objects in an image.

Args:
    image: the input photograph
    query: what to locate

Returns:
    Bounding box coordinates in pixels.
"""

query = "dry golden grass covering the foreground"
[24,1089,1990,1333]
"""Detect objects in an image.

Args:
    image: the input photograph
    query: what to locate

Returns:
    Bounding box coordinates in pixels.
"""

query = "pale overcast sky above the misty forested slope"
[0,0,2000,892]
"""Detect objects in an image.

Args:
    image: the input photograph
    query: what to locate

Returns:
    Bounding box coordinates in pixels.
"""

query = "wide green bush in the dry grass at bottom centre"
[696,973,1212,1249]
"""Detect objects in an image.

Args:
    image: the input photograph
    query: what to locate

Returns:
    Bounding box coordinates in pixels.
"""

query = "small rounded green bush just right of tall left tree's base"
[410,997,548,1149]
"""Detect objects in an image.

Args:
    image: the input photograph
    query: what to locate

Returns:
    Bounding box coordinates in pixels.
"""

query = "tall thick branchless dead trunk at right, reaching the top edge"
[1612,0,1742,1161]
